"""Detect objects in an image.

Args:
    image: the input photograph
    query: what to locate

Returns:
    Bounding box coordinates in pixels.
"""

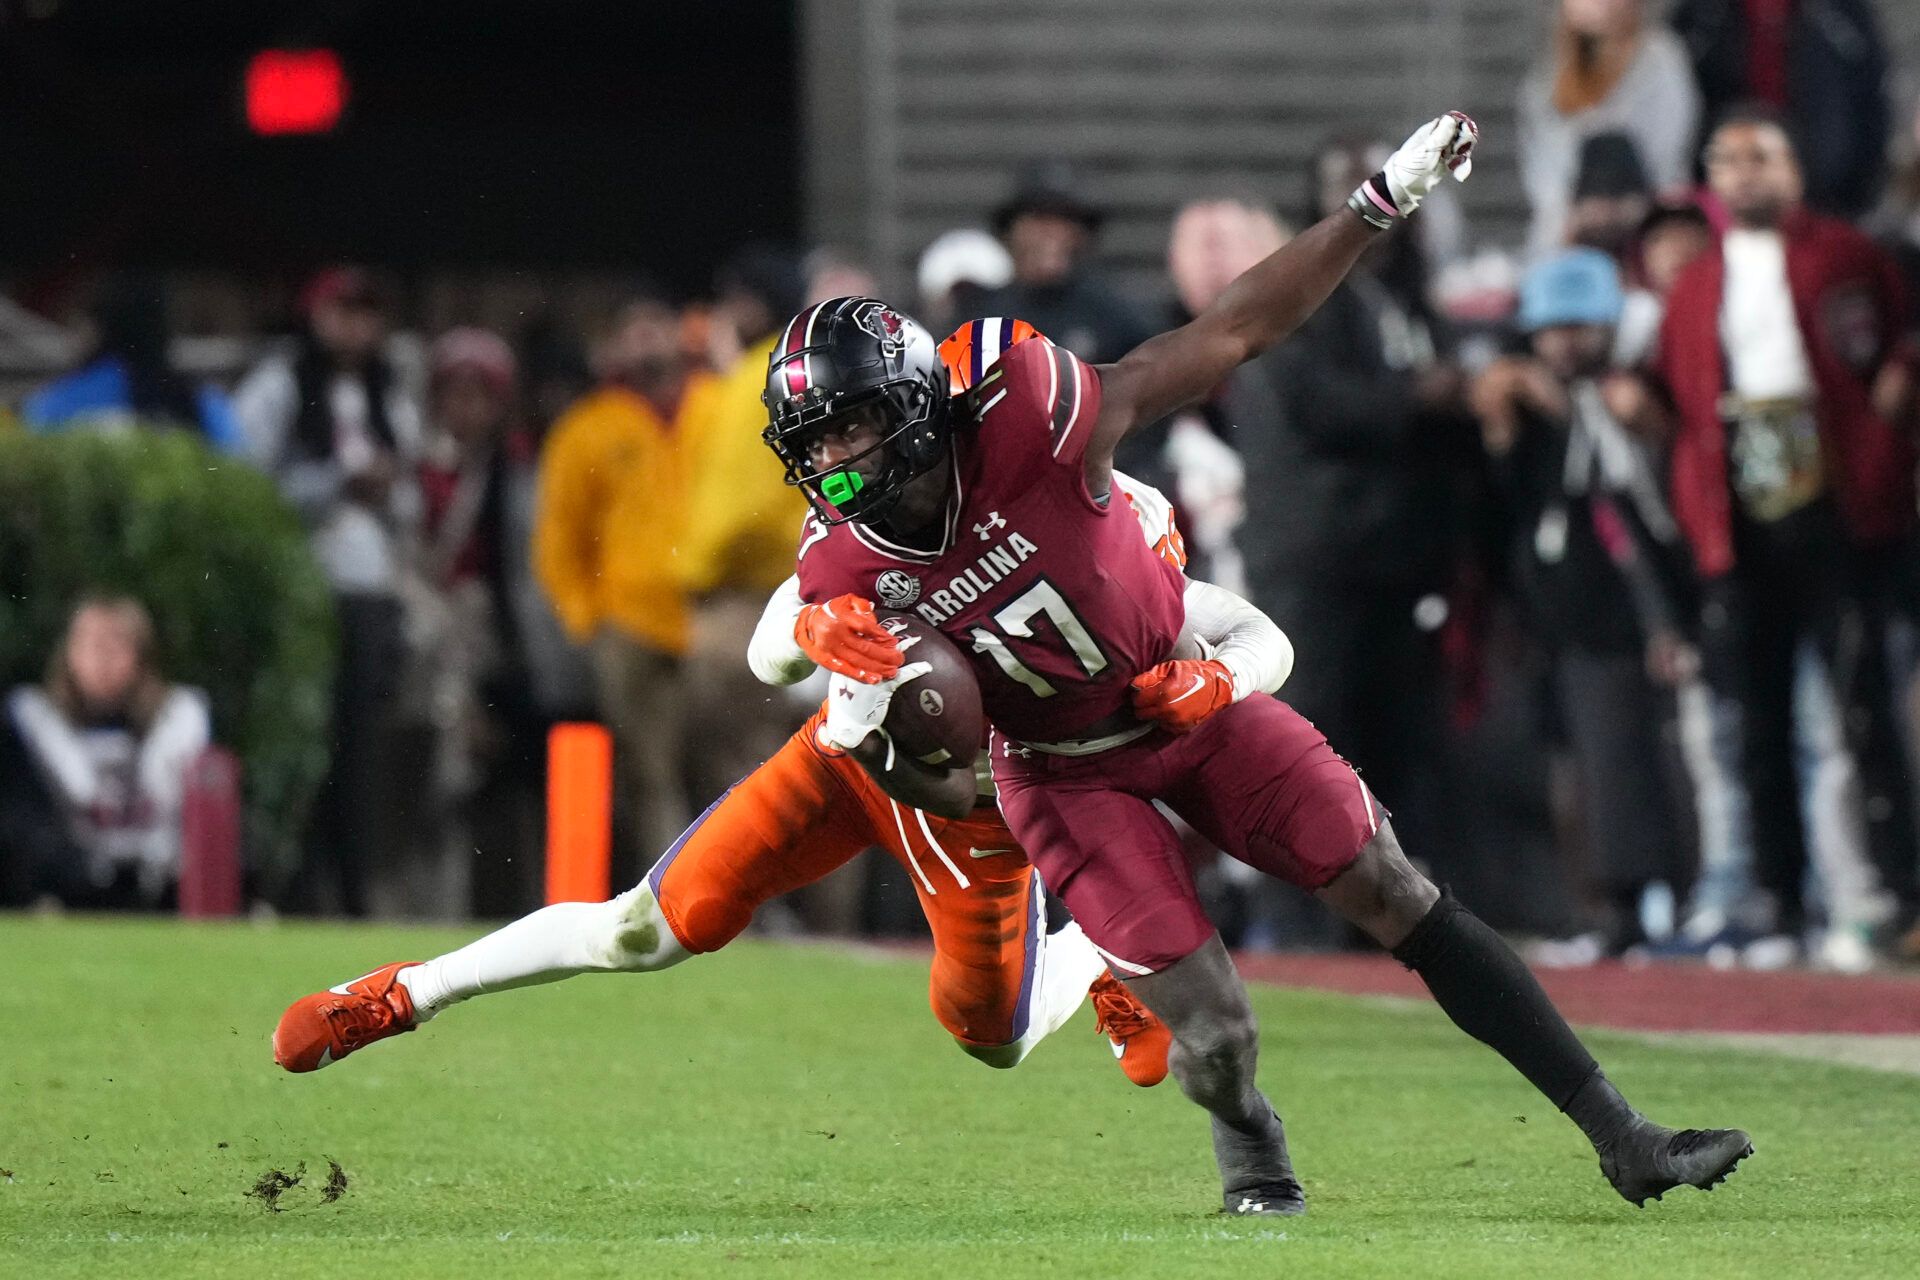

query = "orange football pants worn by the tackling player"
[647,710,1046,1046]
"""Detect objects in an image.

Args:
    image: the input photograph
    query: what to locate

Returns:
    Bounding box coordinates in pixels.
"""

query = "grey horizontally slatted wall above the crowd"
[801,0,1920,297]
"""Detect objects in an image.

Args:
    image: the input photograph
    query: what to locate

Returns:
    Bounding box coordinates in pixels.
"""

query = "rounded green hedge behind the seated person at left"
[0,422,336,890]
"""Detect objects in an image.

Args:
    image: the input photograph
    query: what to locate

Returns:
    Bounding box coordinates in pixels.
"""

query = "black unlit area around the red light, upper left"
[0,0,801,299]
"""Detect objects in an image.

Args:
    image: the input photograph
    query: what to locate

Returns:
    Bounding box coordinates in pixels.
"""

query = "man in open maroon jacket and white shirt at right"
[1659,109,1914,959]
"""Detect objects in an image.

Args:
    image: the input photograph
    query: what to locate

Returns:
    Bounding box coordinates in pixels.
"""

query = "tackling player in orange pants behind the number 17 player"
[275,322,1292,1086]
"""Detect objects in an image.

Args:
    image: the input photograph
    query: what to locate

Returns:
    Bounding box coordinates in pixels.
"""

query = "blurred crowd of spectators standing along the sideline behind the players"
[0,0,1920,969]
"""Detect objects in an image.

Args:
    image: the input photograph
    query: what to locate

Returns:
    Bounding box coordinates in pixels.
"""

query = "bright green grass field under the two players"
[0,917,1920,1280]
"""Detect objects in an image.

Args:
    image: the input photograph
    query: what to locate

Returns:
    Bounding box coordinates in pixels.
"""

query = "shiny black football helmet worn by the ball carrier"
[760,297,952,524]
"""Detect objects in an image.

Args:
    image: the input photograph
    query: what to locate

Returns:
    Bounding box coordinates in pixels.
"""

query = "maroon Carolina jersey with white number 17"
[799,342,1185,743]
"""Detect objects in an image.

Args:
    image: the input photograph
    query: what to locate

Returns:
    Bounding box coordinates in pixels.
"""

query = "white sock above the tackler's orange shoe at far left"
[397,883,687,1023]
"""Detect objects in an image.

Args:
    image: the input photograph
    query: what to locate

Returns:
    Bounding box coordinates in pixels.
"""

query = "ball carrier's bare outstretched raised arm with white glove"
[1087,111,1478,493]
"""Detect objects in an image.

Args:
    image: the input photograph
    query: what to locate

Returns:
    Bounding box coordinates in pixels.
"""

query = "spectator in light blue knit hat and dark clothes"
[1473,249,1695,961]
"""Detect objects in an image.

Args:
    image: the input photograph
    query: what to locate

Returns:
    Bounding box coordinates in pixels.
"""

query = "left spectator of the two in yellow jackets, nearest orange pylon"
[534,297,712,867]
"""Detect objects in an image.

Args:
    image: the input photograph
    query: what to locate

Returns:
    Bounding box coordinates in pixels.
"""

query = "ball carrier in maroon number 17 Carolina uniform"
[766,111,1751,1215]
